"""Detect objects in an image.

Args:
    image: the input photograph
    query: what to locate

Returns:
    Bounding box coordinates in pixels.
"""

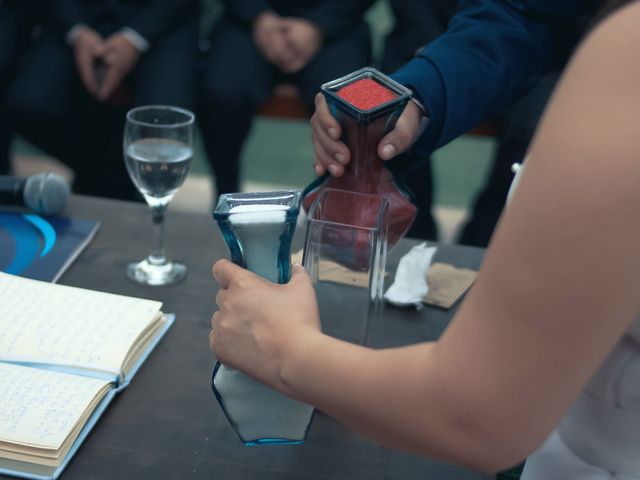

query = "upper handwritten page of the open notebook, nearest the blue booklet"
[0,274,161,373]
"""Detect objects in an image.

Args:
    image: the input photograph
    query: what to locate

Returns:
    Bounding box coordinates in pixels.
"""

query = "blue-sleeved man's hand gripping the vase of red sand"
[311,93,425,177]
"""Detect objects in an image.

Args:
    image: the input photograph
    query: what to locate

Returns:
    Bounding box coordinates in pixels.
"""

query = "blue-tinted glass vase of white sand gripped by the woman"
[211,190,313,445]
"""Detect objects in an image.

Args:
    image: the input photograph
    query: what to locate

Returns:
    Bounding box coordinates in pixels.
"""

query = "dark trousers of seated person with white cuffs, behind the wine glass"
[7,19,197,200]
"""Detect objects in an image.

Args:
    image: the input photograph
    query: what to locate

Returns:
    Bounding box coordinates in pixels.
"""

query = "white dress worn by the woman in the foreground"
[507,162,640,480]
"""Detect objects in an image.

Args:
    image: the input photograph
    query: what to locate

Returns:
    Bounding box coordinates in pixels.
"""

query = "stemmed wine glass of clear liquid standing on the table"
[123,105,195,285]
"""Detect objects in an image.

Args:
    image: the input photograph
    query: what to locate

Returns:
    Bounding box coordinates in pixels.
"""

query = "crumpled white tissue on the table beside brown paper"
[384,243,436,310]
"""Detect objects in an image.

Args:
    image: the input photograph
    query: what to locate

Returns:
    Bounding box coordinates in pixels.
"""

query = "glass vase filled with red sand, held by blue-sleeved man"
[303,67,416,268]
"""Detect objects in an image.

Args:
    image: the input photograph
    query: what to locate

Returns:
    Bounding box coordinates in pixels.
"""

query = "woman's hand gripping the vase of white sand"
[209,260,320,390]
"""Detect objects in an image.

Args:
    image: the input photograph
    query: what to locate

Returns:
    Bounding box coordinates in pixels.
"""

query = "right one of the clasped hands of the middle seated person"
[281,17,323,73]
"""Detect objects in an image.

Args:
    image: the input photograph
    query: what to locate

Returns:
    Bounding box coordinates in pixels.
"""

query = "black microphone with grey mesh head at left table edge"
[0,172,70,215]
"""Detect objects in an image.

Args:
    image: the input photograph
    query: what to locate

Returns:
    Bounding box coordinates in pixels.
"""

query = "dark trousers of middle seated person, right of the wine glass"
[198,18,371,194]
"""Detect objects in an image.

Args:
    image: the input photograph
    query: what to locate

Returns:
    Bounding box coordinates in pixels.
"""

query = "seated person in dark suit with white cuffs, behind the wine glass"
[8,0,199,199]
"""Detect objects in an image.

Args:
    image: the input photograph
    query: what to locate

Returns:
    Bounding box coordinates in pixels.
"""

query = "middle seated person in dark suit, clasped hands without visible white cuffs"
[198,0,372,199]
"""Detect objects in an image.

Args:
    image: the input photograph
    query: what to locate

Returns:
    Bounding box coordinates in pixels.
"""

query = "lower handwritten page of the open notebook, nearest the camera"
[0,363,110,450]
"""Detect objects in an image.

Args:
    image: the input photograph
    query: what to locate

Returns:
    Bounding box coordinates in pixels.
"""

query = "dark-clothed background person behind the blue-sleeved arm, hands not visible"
[382,0,593,247]
